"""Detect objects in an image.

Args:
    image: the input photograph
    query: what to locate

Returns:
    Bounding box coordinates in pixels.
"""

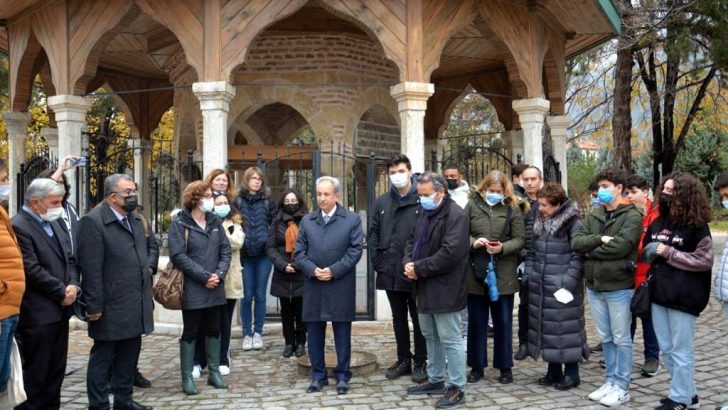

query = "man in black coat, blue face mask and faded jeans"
[404,172,470,407]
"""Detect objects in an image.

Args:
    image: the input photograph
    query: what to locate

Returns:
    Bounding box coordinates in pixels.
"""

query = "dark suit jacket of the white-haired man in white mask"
[11,210,80,328]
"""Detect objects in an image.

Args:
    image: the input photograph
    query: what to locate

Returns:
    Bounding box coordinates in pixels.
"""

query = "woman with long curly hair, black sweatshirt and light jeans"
[642,172,713,410]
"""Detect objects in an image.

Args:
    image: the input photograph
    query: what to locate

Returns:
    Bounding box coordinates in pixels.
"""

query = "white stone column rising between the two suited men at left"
[48,95,91,209]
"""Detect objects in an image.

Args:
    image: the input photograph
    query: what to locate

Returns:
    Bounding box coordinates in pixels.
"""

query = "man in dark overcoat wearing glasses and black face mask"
[77,174,154,410]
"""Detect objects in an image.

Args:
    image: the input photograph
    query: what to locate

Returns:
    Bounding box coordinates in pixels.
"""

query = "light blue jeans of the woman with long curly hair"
[652,303,698,404]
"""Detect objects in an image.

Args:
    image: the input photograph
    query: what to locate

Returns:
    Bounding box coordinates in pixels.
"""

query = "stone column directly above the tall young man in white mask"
[390,82,435,172]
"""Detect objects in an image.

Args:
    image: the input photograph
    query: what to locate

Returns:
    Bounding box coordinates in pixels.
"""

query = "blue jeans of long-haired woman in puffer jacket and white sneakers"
[240,255,273,336]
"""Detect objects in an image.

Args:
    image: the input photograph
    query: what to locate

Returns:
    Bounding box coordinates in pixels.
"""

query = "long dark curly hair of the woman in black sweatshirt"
[657,172,711,227]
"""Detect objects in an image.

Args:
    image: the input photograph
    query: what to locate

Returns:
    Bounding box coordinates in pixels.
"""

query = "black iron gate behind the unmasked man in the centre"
[251,143,389,320]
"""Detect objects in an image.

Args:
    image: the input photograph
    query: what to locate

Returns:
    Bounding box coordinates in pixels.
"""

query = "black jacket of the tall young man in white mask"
[368,176,422,292]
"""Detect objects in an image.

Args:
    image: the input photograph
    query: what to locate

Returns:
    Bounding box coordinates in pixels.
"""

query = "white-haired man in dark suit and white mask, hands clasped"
[12,178,80,409]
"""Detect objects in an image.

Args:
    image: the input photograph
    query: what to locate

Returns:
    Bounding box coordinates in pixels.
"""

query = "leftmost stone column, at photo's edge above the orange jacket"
[3,111,32,216]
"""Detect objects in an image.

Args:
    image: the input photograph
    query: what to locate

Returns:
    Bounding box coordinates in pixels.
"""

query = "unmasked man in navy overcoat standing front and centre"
[294,177,364,394]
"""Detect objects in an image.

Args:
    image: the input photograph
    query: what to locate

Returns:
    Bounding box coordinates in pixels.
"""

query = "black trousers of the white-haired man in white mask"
[15,320,68,410]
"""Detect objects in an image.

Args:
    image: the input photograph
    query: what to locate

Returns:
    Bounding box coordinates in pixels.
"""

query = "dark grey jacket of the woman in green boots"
[168,209,232,310]
